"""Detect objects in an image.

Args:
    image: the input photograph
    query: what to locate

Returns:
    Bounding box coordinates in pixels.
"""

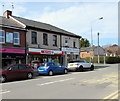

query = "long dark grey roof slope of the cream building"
[12,16,81,38]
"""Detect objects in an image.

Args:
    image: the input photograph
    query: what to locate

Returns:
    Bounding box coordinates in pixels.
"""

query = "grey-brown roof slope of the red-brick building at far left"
[0,16,24,29]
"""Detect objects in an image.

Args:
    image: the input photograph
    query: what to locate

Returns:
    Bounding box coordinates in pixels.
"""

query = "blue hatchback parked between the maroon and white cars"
[38,62,68,76]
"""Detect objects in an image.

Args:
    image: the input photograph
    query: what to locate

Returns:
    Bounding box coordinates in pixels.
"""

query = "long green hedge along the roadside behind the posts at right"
[81,56,120,64]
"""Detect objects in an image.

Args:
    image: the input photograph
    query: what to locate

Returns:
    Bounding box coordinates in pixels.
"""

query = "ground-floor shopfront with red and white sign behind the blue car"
[27,48,64,65]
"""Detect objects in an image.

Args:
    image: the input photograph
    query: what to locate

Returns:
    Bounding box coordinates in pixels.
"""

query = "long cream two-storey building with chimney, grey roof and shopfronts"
[4,10,81,65]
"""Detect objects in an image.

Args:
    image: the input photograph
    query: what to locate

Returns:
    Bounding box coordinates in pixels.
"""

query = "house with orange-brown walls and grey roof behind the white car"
[80,46,105,58]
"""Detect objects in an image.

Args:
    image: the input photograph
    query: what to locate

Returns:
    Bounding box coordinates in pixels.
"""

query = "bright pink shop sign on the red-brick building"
[0,48,25,54]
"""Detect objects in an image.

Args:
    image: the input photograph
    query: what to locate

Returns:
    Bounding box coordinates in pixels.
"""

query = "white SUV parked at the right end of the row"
[67,60,94,72]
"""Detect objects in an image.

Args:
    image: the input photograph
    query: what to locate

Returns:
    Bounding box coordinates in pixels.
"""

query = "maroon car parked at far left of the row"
[0,64,34,82]
